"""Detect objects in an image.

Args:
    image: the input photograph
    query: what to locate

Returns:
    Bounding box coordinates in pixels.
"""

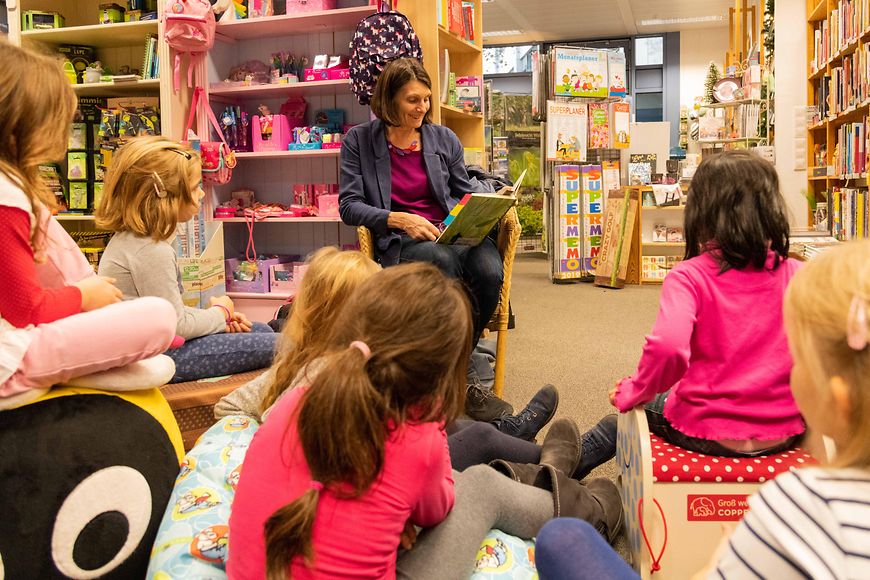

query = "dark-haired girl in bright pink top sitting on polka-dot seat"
[610,151,804,456]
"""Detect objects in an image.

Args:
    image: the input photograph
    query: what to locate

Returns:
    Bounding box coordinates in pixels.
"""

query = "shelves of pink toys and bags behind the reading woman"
[200,0,375,320]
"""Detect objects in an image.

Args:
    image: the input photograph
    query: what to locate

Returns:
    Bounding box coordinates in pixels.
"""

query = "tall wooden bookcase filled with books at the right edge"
[806,0,870,231]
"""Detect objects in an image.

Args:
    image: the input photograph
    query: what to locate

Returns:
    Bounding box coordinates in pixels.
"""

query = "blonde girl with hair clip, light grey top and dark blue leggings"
[96,137,278,383]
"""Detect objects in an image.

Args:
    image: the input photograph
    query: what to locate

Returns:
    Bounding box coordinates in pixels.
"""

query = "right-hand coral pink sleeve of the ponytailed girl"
[411,429,454,528]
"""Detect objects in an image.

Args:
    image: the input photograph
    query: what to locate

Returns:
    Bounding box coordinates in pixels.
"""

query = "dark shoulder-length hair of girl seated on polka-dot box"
[684,151,789,272]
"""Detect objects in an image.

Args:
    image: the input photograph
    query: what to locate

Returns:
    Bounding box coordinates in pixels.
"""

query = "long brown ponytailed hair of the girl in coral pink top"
[264,263,472,580]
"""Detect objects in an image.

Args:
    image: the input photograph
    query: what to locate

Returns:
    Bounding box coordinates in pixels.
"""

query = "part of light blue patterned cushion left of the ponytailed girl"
[147,416,259,580]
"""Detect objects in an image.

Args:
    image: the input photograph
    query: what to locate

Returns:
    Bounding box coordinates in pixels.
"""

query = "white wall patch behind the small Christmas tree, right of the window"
[680,26,728,107]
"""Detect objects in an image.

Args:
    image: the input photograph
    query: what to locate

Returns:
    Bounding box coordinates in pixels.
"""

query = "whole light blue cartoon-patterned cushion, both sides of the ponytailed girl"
[147,416,538,580]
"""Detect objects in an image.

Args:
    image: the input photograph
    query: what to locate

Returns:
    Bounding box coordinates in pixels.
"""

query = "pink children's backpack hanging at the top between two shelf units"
[162,0,215,91]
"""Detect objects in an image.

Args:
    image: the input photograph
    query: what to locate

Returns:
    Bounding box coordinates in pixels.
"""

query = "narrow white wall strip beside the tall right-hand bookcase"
[774,0,807,229]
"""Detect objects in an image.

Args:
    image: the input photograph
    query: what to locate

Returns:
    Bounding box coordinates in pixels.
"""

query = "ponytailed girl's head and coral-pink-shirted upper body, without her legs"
[227,263,472,579]
